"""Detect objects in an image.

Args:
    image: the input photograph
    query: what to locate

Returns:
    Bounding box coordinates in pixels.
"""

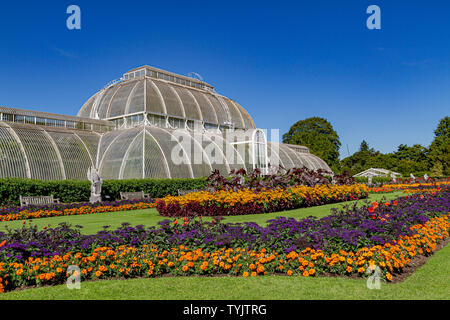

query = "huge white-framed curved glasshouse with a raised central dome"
[0,66,331,180]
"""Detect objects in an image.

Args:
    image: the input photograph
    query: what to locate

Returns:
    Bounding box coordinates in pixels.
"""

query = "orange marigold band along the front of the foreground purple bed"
[0,214,450,292]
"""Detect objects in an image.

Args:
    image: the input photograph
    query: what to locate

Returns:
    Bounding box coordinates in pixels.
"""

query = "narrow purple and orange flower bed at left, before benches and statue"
[0,200,155,221]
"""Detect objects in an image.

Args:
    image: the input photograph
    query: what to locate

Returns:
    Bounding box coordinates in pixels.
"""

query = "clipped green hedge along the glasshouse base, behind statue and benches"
[0,178,206,206]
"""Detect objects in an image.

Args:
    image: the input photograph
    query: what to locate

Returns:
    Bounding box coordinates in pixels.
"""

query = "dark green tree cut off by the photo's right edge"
[428,117,450,176]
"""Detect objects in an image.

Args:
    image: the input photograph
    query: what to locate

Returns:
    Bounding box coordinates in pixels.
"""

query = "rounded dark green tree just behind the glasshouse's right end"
[283,117,341,171]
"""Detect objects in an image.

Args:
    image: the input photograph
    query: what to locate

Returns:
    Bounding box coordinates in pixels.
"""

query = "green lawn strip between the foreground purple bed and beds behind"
[0,192,403,234]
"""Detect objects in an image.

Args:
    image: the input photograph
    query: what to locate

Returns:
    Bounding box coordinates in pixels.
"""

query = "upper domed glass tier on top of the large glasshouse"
[78,66,255,129]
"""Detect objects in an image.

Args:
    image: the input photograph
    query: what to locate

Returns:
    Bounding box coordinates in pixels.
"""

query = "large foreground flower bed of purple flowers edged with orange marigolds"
[0,190,450,291]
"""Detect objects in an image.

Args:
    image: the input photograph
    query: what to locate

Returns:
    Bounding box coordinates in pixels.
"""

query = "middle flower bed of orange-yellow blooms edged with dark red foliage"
[156,184,368,217]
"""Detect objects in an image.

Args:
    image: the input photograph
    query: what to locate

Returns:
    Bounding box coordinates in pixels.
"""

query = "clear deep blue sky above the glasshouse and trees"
[0,0,450,157]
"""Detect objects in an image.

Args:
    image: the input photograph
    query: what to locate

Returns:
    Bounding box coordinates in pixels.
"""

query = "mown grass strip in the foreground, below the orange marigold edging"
[0,240,450,300]
